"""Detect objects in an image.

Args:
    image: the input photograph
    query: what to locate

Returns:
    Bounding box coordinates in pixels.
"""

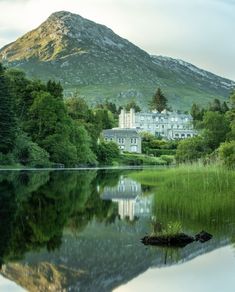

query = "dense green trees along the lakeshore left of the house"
[0,64,119,167]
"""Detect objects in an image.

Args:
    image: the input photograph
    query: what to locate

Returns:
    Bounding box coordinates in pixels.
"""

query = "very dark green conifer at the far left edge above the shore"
[0,64,16,154]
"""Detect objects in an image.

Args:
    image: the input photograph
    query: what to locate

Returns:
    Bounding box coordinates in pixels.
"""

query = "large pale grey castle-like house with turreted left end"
[119,109,196,140]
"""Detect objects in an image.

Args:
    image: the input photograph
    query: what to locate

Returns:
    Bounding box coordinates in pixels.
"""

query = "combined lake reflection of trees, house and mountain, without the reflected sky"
[0,170,234,291]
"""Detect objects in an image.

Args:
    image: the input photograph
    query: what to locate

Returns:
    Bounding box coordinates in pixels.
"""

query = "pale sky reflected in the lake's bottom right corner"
[114,246,235,292]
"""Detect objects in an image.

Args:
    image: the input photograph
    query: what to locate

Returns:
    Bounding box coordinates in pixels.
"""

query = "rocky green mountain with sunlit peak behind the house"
[0,11,235,109]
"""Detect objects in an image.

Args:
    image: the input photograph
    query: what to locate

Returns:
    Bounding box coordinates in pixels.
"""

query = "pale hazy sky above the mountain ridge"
[0,0,235,80]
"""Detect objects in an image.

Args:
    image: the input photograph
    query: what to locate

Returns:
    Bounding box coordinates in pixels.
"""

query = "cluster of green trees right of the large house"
[176,91,235,167]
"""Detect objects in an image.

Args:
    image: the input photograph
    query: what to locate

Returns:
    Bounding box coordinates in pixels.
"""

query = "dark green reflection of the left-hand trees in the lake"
[0,171,119,264]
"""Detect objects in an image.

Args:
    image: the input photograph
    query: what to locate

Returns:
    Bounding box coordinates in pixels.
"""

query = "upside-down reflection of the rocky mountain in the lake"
[0,222,230,292]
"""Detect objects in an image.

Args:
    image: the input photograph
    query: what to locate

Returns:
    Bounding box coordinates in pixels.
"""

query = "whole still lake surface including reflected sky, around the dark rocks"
[0,169,235,292]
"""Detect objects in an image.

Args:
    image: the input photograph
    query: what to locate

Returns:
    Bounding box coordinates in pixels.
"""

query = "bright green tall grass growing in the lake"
[132,164,235,235]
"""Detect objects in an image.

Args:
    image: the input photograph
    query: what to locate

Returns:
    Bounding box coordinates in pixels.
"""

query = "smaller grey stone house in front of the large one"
[102,128,141,153]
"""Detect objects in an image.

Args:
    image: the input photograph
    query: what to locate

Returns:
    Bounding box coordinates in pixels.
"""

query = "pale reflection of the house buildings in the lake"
[102,176,152,220]
